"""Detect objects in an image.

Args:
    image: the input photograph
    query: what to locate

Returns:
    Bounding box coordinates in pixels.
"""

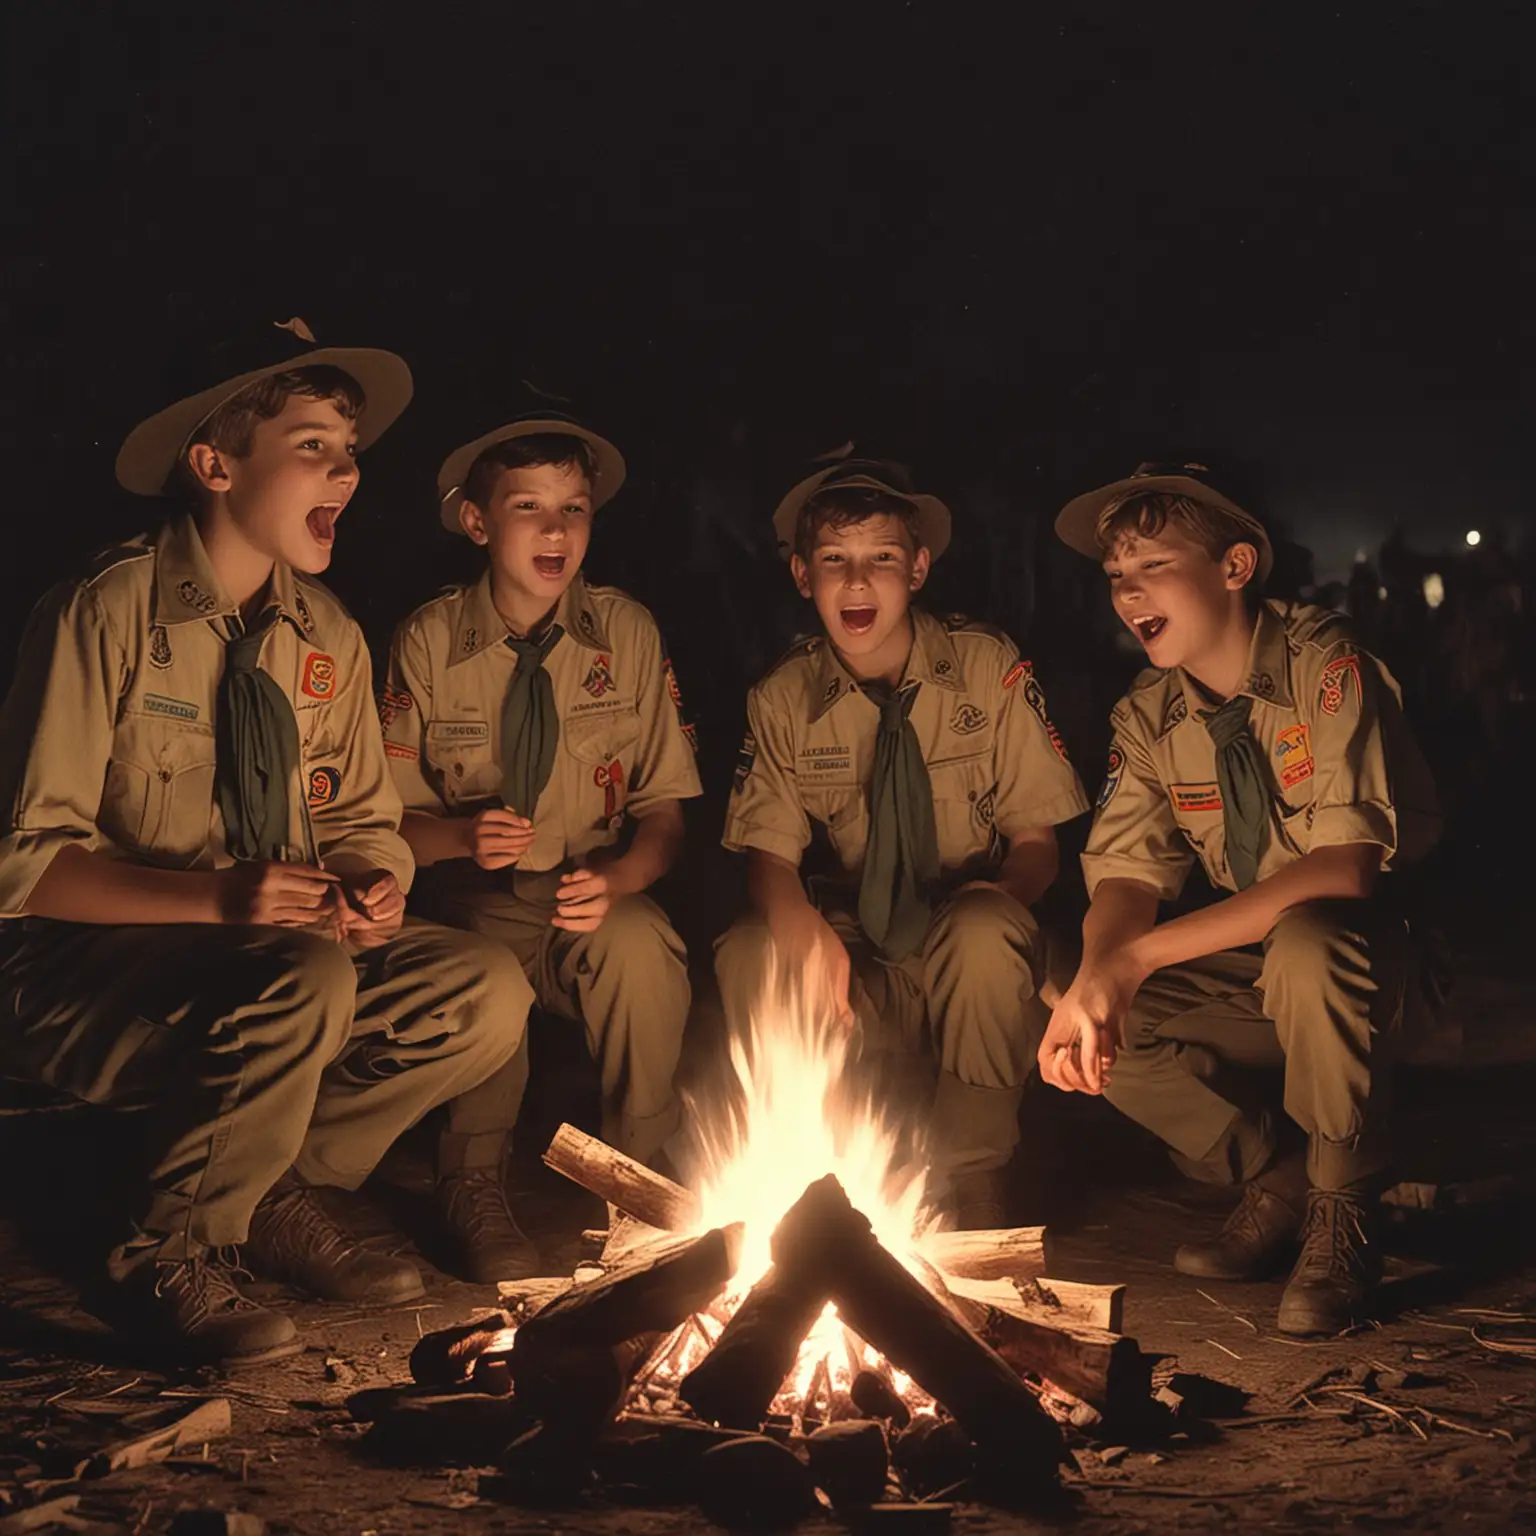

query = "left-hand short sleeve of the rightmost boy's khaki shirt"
[1083,707,1195,902]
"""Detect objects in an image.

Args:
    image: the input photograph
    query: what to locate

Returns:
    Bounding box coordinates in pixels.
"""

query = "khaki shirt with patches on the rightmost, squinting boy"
[1083,602,1439,900]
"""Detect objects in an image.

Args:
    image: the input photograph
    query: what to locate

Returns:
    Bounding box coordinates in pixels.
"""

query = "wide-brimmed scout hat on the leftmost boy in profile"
[117,315,412,496]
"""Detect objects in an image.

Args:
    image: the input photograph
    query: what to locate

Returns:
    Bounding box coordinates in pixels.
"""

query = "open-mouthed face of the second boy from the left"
[459,464,591,619]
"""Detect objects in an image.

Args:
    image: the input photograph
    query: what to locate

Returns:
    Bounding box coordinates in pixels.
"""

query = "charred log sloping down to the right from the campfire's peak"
[774,1174,1061,1481]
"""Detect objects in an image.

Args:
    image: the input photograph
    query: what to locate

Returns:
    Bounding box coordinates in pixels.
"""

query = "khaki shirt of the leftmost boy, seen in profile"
[0,516,413,917]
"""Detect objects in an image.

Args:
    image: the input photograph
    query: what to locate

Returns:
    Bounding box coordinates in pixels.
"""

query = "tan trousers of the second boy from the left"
[412,865,691,1163]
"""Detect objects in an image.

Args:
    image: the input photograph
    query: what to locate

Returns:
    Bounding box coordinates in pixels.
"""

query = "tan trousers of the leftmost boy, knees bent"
[0,919,528,1247]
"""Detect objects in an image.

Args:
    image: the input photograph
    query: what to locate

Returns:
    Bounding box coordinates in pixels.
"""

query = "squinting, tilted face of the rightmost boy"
[1104,525,1256,670]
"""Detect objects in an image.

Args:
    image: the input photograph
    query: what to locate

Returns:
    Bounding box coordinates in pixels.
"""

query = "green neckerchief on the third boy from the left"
[859,682,938,960]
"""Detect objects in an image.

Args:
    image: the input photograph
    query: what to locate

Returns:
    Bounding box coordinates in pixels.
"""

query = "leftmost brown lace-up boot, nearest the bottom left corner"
[101,1250,304,1366]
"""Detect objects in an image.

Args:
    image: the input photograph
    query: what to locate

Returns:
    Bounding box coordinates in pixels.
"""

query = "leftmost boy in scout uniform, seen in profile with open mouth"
[0,321,527,1358]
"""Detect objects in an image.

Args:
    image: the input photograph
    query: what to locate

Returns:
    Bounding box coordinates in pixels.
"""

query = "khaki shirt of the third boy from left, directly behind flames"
[723,608,1087,883]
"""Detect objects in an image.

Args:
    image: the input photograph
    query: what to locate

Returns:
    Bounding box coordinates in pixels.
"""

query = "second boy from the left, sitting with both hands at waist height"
[381,415,700,1278]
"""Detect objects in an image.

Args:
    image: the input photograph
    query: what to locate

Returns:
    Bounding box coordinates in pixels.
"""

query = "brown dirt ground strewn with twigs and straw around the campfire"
[0,946,1536,1536]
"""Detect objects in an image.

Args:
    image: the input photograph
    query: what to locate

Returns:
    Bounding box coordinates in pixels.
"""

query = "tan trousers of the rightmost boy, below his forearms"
[1104,900,1409,1189]
